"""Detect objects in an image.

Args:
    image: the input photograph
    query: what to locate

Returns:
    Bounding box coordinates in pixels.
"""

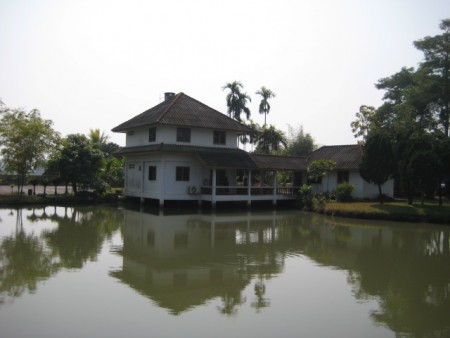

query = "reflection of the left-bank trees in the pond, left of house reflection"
[0,207,122,304]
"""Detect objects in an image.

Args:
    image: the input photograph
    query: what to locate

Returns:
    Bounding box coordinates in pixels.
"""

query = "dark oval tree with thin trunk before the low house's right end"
[359,133,395,204]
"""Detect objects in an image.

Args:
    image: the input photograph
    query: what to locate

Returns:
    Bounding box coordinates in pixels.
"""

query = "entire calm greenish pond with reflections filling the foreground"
[0,207,450,338]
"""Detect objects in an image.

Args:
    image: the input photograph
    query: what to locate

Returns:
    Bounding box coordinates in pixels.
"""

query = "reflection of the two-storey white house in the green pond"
[112,210,288,314]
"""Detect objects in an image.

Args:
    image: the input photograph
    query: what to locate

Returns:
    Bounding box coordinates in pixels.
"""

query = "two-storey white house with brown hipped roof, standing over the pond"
[112,93,394,206]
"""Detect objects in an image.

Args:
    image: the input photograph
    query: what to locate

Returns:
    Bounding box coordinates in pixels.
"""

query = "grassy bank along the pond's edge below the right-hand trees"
[324,201,450,224]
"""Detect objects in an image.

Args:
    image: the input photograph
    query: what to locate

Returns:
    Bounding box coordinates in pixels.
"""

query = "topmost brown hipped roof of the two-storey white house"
[112,93,251,133]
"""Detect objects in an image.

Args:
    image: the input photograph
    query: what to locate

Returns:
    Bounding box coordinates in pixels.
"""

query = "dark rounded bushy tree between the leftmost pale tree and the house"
[54,134,102,193]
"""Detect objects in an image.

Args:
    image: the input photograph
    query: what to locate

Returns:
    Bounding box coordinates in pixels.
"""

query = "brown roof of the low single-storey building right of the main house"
[308,144,363,169]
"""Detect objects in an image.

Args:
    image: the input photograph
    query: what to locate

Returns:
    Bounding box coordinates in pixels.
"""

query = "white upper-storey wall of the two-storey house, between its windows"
[125,125,237,148]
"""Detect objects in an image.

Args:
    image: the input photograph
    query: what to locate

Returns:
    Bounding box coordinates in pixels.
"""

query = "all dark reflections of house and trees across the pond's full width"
[0,207,450,337]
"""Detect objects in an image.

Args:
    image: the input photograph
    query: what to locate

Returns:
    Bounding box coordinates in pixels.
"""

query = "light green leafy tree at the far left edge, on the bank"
[0,102,58,192]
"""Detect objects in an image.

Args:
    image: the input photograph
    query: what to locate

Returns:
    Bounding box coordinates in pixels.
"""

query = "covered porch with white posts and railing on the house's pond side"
[198,153,306,207]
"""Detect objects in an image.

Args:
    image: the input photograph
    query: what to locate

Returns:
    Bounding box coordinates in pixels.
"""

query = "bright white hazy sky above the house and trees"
[0,0,450,146]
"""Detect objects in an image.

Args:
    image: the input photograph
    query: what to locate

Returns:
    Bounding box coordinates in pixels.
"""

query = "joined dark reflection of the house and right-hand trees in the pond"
[112,210,450,337]
